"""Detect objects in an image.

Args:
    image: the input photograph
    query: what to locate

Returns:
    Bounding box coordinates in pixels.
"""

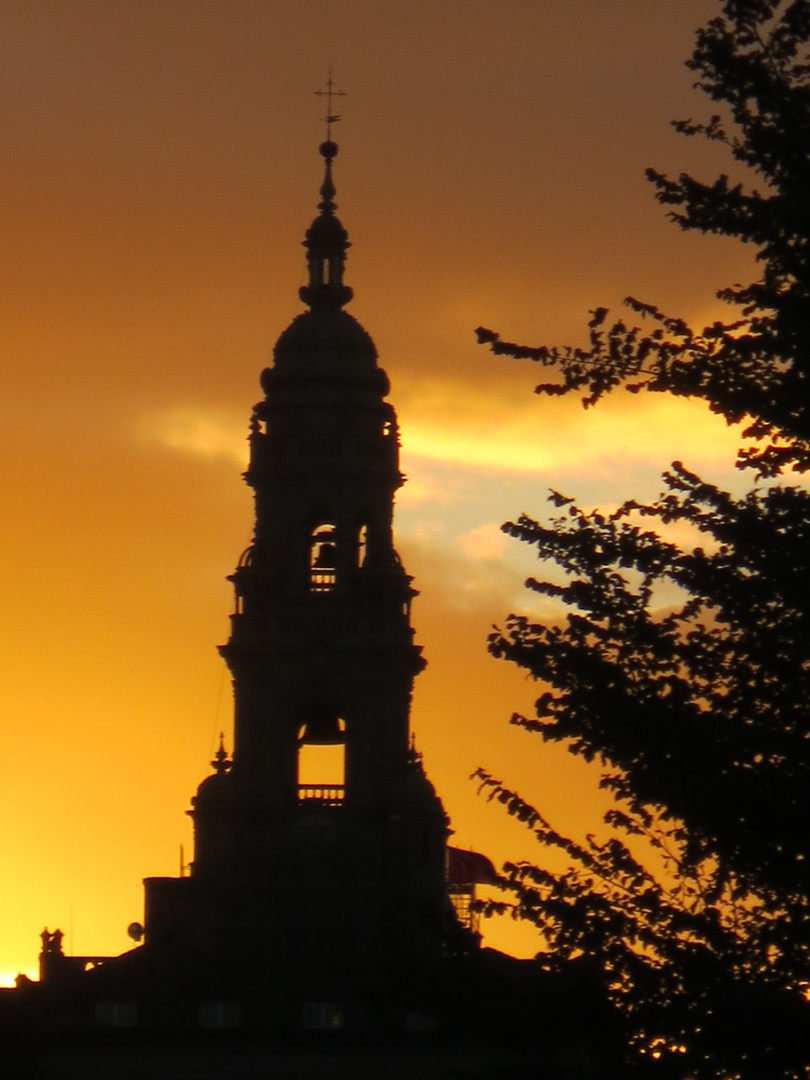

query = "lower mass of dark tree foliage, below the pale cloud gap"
[478,465,810,1076]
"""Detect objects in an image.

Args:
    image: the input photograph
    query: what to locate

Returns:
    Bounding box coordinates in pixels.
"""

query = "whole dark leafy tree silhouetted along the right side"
[477,0,810,1077]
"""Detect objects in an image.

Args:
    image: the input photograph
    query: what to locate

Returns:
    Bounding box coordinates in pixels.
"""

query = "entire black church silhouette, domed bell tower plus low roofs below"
[6,132,611,1080]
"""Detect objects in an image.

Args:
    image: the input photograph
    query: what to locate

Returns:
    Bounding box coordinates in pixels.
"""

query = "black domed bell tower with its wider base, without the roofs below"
[146,133,448,1000]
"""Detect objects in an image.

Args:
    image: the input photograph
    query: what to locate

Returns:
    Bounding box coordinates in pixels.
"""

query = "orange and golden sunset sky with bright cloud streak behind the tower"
[0,0,755,982]
